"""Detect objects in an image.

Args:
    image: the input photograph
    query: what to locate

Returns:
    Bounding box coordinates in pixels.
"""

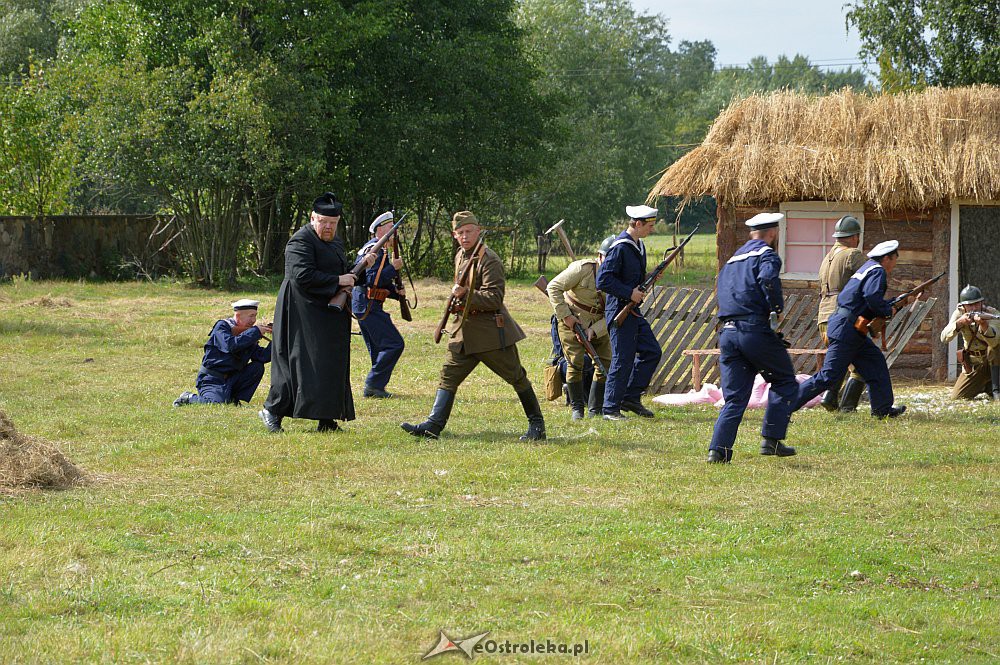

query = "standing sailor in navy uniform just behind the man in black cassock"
[351,212,406,398]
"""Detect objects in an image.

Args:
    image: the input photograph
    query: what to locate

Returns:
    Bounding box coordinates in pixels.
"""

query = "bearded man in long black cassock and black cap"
[258,192,375,432]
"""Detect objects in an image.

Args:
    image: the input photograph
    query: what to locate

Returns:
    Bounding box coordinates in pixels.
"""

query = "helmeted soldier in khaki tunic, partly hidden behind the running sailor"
[817,215,867,411]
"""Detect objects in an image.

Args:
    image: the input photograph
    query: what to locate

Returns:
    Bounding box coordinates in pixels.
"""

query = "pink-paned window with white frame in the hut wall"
[778,201,865,280]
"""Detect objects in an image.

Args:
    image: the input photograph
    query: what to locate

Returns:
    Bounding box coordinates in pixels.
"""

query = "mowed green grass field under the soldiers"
[0,268,1000,663]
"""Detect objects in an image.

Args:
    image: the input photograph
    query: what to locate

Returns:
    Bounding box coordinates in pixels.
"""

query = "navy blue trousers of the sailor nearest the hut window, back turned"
[708,321,799,450]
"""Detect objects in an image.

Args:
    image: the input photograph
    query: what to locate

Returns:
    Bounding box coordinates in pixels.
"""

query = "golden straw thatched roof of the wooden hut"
[650,86,1000,211]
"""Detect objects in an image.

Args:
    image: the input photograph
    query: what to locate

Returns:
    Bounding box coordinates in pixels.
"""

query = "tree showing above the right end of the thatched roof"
[847,0,1000,90]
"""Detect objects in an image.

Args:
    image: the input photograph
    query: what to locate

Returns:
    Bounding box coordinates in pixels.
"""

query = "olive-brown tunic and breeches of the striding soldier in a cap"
[438,245,531,393]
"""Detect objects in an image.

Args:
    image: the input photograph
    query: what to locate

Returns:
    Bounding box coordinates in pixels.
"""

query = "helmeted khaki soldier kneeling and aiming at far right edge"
[941,284,1000,400]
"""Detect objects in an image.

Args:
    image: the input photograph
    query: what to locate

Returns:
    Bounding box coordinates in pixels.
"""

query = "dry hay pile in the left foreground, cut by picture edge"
[0,411,83,489]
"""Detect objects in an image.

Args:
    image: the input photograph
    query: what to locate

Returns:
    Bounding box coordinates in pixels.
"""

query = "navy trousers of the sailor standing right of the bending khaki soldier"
[604,315,663,413]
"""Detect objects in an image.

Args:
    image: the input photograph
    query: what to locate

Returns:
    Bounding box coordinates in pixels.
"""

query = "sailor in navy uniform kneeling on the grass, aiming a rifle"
[174,300,271,406]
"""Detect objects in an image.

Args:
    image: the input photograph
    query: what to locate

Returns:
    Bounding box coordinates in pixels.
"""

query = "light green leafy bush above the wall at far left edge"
[0,71,78,216]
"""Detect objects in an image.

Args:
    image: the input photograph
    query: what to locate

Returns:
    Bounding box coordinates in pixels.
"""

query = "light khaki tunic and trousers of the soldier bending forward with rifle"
[548,259,611,383]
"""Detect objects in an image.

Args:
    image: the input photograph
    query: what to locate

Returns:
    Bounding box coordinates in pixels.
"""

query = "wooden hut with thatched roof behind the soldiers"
[650,86,1000,379]
